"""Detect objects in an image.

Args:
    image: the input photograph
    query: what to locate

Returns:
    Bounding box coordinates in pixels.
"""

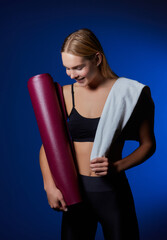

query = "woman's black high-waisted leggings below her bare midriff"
[61,173,139,240]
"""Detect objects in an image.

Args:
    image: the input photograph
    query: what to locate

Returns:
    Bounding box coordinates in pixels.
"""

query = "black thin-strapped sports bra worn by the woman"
[68,84,100,142]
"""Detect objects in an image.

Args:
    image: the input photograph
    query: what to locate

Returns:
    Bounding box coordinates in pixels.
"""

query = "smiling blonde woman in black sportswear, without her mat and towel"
[40,29,155,240]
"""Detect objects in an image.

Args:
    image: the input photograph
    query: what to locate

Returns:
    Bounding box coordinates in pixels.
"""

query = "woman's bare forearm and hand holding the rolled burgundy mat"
[39,145,67,211]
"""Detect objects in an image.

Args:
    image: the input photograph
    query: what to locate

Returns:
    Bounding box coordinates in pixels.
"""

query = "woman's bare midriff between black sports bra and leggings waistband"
[73,142,123,176]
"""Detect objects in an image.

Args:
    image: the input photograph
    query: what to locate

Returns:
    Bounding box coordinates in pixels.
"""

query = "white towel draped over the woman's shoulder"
[90,77,145,160]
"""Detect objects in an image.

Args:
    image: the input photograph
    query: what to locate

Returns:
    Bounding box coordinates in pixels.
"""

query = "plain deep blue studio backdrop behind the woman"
[0,0,167,240]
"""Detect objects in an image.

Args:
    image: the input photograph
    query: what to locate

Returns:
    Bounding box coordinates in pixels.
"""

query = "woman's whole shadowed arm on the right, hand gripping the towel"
[90,86,156,175]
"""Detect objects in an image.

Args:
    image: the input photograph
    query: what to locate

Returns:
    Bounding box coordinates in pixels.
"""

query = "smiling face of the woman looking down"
[62,52,99,86]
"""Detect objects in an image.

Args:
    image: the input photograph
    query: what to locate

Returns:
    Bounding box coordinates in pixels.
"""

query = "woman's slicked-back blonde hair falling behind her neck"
[61,28,118,79]
